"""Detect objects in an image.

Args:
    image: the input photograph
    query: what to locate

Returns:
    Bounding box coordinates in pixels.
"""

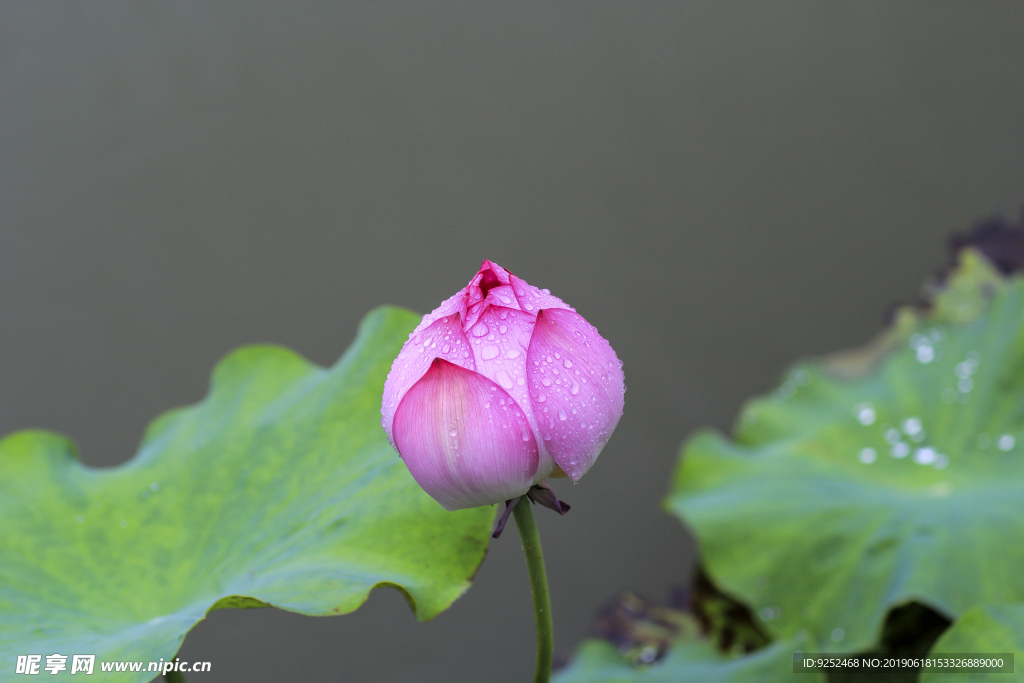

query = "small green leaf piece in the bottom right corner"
[921,604,1024,683]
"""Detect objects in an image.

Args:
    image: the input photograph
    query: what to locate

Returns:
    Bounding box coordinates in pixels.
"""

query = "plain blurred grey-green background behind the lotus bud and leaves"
[0,0,1024,683]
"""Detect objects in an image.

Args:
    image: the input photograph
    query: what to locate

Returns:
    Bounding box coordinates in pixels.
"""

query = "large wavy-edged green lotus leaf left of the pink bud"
[0,308,494,683]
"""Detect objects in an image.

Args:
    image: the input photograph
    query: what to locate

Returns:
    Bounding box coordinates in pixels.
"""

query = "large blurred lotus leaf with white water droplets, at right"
[666,250,1024,651]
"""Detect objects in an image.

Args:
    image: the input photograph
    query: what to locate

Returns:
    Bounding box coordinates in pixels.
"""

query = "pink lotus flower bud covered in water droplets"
[381,261,626,510]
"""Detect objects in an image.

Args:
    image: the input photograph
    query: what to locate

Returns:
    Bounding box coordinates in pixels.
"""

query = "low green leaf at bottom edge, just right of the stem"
[552,639,825,683]
